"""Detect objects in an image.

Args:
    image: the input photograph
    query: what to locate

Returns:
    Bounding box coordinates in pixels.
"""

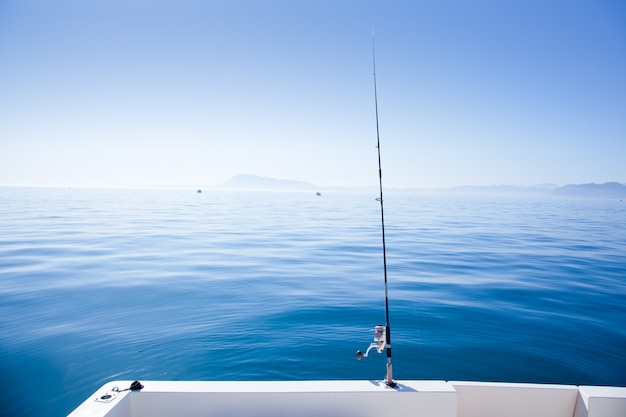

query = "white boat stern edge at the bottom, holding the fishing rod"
[70,380,626,417]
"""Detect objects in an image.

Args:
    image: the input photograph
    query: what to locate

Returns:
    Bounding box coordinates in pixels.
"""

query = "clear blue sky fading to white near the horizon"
[0,0,626,187]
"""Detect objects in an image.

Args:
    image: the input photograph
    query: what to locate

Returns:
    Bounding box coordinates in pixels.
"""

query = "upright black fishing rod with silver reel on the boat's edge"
[356,32,396,388]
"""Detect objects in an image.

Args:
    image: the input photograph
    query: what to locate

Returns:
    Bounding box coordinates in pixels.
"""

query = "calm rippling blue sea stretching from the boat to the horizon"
[0,188,626,416]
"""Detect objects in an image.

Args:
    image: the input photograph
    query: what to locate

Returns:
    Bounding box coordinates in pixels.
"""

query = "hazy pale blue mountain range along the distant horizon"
[219,174,626,199]
